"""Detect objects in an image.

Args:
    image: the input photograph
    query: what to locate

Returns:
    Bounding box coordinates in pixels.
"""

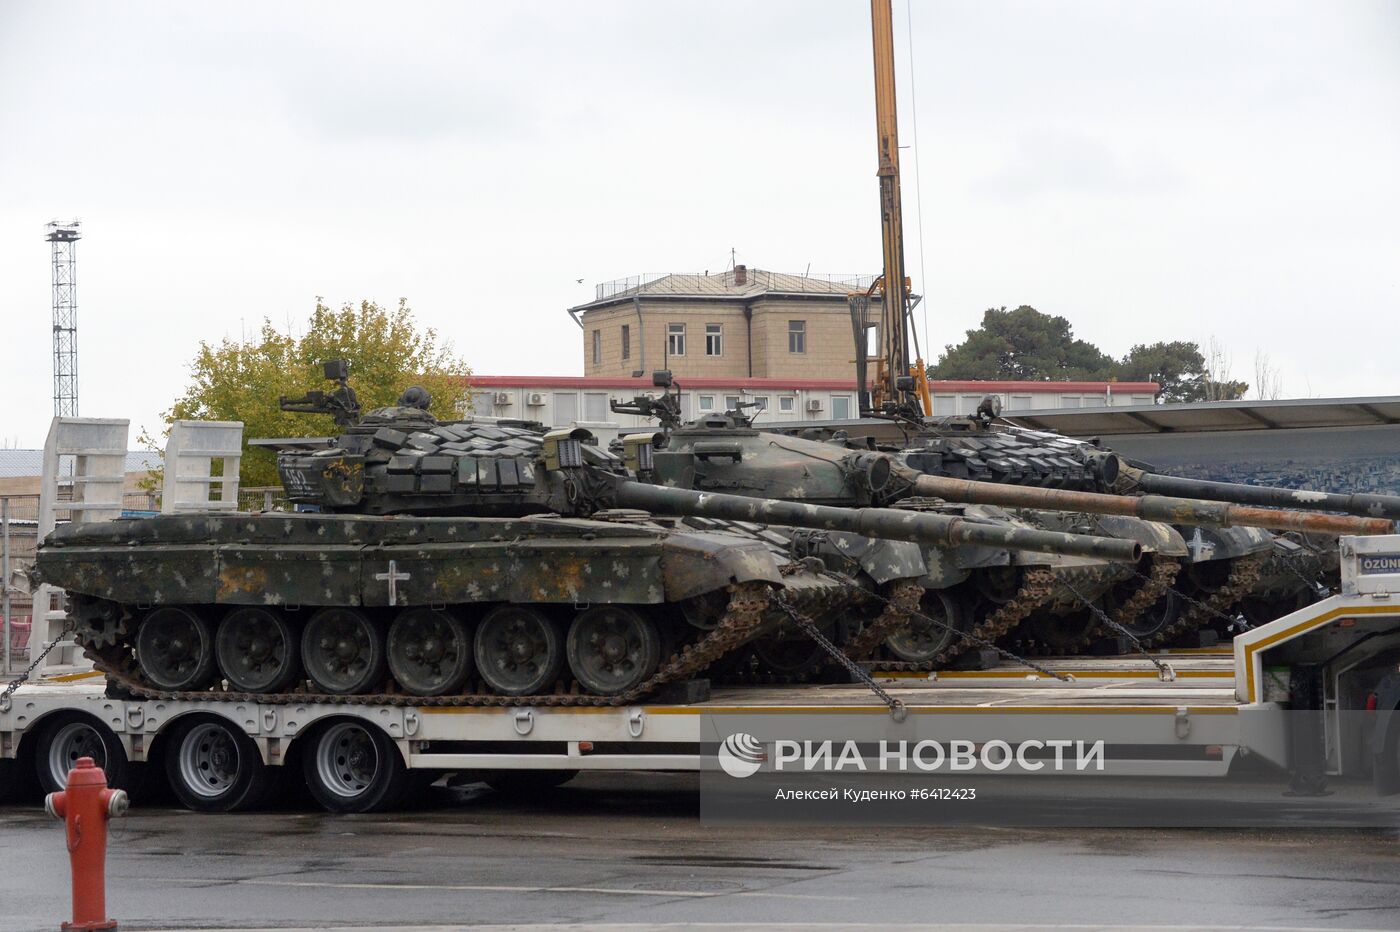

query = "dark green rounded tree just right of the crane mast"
[928,304,1117,382]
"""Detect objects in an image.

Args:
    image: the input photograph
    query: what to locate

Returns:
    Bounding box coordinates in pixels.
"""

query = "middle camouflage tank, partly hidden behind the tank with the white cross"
[613,372,1186,672]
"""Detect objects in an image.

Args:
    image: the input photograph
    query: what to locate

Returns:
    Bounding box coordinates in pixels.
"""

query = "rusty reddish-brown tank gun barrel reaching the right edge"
[914,474,1394,535]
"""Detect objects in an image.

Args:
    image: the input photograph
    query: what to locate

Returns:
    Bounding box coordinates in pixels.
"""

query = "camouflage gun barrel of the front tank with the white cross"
[613,481,1142,561]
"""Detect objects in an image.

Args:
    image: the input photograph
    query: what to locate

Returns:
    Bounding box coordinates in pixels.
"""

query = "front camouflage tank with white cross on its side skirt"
[35,365,1121,705]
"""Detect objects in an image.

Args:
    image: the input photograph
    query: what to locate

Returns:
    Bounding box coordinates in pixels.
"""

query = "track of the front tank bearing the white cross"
[77,582,774,708]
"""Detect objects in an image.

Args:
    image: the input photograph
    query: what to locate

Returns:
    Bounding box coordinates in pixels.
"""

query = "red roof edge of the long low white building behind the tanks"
[468,375,1159,391]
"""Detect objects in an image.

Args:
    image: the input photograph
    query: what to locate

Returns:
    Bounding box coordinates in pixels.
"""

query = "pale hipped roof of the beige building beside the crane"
[570,266,875,313]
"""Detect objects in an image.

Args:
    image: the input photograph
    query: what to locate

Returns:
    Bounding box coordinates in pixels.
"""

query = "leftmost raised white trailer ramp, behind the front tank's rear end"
[29,417,130,673]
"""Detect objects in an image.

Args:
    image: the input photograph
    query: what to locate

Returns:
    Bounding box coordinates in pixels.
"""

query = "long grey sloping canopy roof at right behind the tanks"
[1002,396,1400,437]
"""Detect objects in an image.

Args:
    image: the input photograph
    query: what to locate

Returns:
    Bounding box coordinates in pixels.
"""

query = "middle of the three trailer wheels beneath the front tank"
[165,716,272,812]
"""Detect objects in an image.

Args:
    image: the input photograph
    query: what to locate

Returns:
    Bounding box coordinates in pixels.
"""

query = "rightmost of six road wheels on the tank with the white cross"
[567,605,661,696]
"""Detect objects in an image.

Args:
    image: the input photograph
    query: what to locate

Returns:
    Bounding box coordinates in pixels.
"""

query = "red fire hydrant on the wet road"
[43,757,130,932]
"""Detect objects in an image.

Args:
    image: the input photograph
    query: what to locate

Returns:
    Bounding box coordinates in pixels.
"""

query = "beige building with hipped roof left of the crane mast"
[568,266,879,381]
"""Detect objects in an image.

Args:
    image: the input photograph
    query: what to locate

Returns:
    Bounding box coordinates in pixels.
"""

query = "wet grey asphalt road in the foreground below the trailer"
[0,774,1400,932]
